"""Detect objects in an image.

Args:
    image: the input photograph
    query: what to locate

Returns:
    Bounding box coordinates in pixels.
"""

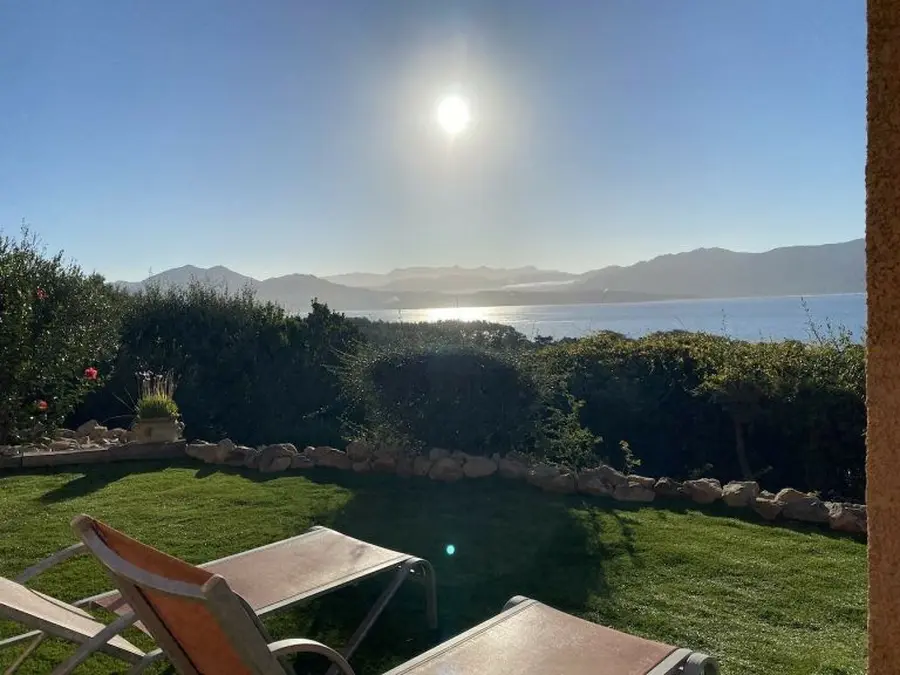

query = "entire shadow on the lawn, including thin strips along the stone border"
[14,459,860,675]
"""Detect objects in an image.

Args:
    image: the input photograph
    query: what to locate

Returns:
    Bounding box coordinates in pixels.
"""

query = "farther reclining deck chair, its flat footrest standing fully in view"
[0,527,437,675]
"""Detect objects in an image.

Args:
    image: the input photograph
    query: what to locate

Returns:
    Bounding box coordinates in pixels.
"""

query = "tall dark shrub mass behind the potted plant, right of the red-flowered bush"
[75,284,356,445]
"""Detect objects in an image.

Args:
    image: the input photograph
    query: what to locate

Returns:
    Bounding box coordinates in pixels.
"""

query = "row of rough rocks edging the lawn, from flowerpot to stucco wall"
[185,438,868,534]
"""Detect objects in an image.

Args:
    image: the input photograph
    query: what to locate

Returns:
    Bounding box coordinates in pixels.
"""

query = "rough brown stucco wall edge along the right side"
[866,0,900,675]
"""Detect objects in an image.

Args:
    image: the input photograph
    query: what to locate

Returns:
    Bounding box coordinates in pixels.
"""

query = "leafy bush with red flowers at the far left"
[0,231,121,444]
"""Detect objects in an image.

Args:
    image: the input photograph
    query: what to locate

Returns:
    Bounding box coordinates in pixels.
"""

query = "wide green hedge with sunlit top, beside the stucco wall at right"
[543,332,866,500]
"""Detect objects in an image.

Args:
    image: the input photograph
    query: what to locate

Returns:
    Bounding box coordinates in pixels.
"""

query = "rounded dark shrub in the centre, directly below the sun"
[340,343,594,463]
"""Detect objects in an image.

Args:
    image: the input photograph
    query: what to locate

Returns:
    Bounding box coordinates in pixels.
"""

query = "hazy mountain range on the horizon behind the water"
[118,239,865,312]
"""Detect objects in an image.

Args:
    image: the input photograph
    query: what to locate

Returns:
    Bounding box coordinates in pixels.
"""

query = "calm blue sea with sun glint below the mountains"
[345,293,866,341]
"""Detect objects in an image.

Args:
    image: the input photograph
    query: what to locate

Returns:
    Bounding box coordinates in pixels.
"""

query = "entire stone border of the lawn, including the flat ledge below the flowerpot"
[0,430,868,534]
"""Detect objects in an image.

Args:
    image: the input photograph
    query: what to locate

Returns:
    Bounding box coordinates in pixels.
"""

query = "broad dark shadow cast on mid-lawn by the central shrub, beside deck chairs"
[270,471,622,672]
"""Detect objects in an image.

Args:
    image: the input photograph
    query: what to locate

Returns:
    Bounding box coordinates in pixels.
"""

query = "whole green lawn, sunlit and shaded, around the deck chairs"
[0,463,866,675]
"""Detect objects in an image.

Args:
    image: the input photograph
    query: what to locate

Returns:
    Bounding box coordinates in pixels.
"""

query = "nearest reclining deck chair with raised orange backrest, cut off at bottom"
[72,516,718,675]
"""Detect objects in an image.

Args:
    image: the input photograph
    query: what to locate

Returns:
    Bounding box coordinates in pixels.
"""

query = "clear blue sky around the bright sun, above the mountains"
[0,0,866,280]
